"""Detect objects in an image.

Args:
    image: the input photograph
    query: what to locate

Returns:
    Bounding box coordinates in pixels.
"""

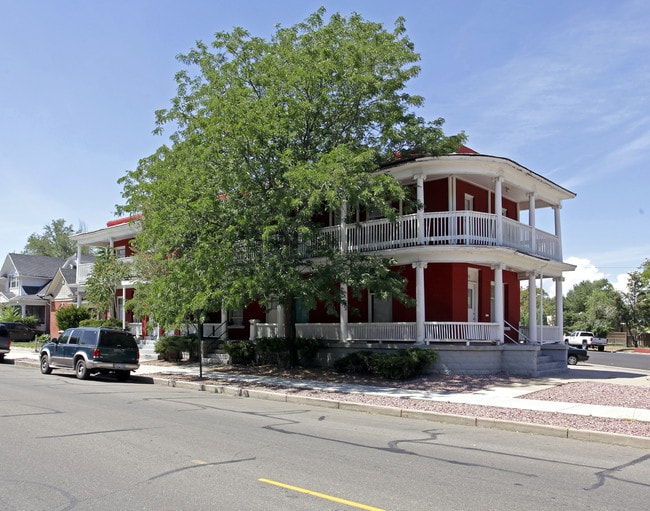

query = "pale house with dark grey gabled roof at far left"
[0,254,65,332]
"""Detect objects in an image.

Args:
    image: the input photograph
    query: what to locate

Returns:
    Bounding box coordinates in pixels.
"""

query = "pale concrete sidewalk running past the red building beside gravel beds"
[6,348,650,448]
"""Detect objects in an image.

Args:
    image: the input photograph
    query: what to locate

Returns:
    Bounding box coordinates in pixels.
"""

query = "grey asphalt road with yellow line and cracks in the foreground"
[0,364,650,511]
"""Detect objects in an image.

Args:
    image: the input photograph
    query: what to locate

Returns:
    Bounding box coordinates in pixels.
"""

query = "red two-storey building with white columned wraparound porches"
[67,147,575,375]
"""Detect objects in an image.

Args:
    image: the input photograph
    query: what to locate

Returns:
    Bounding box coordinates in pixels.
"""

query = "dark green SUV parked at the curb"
[40,327,140,381]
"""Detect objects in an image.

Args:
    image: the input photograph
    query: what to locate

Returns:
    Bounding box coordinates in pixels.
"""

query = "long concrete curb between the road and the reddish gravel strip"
[148,378,650,449]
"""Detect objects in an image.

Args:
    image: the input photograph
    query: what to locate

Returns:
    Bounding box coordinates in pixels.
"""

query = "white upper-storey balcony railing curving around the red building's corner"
[323,211,561,260]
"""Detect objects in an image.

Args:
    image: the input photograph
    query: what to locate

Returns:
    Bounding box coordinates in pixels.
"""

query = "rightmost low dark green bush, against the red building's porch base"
[334,348,438,380]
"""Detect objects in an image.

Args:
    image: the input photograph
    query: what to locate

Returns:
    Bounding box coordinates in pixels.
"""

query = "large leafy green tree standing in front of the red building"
[115,8,464,360]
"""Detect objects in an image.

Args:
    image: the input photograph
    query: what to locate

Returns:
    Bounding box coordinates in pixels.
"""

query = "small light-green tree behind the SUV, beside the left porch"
[85,247,131,318]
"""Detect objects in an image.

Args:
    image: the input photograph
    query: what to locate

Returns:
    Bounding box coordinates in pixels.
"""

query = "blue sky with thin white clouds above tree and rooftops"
[0,0,650,291]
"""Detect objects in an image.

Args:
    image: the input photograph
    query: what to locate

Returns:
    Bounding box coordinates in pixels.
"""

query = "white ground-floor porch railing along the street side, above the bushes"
[250,321,499,343]
